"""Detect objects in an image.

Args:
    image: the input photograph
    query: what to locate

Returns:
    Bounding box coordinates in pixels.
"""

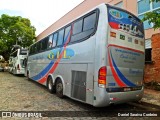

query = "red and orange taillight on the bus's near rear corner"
[98,66,107,88]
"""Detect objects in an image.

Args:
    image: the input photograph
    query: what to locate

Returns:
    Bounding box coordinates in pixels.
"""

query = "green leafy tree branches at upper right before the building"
[142,0,160,29]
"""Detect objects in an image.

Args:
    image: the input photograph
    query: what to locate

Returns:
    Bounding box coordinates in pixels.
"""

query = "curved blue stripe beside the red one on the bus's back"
[111,51,136,87]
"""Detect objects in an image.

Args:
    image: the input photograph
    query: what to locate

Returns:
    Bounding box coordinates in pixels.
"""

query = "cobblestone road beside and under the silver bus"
[0,72,158,120]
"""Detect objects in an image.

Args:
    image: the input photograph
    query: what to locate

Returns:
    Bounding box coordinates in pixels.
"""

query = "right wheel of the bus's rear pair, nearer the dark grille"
[56,80,64,98]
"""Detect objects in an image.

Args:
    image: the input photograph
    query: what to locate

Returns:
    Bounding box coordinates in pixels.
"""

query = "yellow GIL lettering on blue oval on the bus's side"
[48,49,74,60]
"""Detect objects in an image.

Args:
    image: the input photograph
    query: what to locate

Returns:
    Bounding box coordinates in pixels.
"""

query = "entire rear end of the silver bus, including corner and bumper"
[94,5,144,107]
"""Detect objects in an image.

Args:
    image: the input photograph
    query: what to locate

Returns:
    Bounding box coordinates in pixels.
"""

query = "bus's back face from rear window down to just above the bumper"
[106,6,145,87]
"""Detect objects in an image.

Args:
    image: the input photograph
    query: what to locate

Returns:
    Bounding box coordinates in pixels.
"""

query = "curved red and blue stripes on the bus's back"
[108,45,140,87]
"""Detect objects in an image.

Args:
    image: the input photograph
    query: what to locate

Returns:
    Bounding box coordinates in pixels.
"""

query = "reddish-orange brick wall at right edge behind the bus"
[144,33,160,83]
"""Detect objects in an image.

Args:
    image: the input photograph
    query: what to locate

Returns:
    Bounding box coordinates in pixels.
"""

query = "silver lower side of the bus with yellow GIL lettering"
[28,28,95,104]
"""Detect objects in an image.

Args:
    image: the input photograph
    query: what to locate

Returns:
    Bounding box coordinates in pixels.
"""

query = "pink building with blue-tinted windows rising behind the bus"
[37,0,160,81]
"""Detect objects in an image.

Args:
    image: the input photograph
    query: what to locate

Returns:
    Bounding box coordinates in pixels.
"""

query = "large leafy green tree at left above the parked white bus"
[0,14,36,59]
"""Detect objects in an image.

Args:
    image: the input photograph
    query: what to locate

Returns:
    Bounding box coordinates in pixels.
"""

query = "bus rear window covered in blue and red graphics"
[107,5,144,38]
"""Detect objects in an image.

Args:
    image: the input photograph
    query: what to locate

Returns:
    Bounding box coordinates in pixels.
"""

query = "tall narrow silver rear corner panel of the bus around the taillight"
[93,5,109,107]
